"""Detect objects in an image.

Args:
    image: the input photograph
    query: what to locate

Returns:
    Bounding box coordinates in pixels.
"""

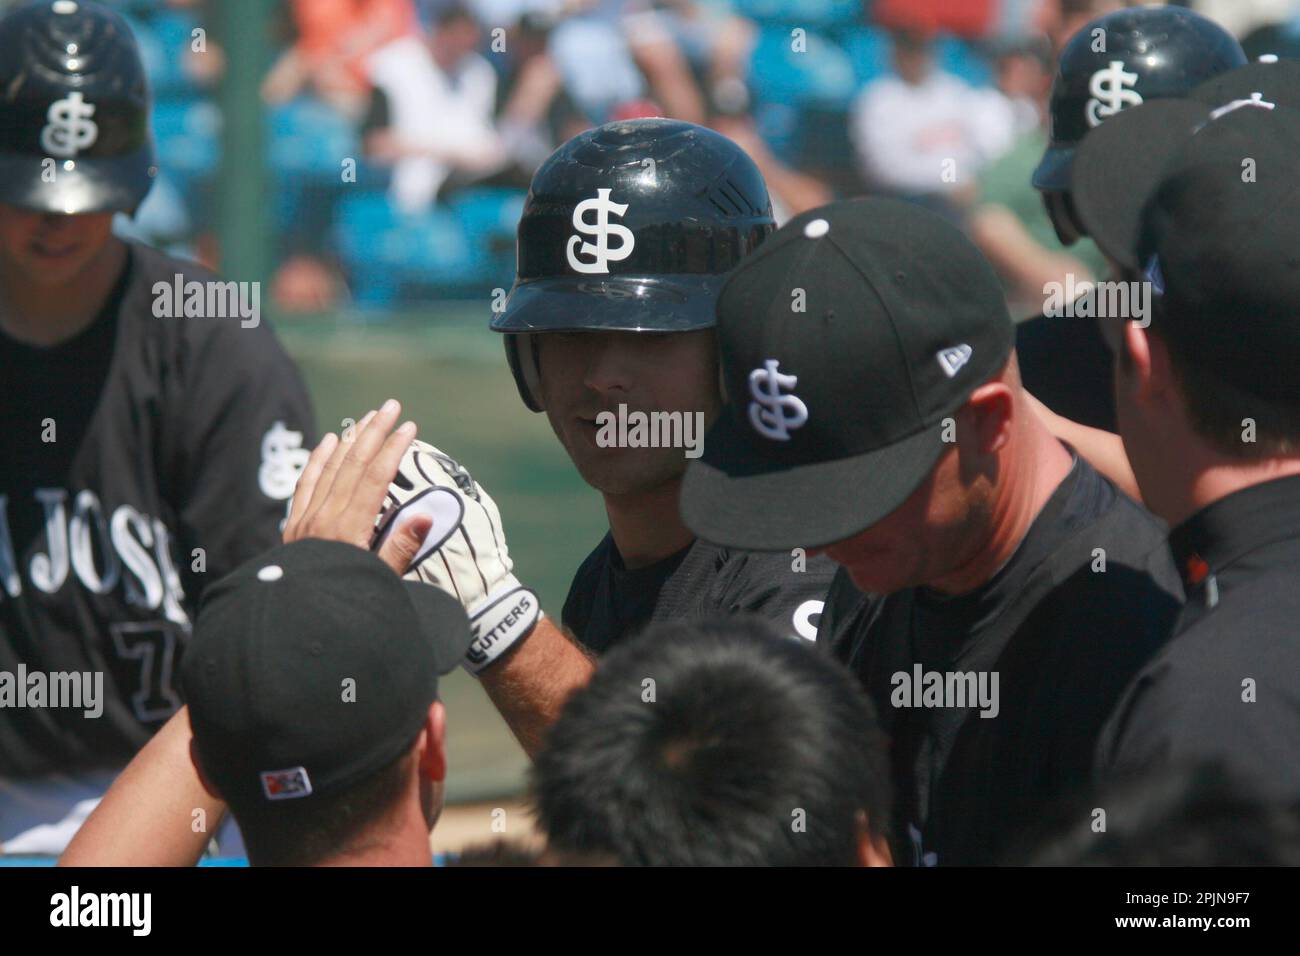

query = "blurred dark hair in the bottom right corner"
[1010,763,1300,866]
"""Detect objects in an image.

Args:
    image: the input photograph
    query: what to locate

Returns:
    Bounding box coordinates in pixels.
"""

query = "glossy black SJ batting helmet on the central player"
[491,118,776,411]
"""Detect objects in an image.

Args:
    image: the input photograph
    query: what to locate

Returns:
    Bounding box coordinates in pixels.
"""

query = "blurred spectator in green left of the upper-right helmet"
[970,38,1105,317]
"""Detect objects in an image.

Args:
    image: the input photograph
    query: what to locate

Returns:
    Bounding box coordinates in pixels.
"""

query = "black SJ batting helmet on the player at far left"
[0,0,157,215]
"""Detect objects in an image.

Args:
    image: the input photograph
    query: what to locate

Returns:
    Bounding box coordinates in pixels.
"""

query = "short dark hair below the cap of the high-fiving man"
[230,737,415,866]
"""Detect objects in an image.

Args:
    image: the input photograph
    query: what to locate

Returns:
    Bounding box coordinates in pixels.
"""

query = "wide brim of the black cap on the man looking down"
[681,416,950,551]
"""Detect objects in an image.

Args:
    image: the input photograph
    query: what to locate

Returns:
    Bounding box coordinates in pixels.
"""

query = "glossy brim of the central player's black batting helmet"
[491,274,724,332]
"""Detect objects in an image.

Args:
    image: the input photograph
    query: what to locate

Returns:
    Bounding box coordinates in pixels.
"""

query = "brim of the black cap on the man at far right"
[1073,99,1210,269]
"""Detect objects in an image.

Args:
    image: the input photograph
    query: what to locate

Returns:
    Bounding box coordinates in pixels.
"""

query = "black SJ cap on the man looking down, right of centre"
[681,198,1014,550]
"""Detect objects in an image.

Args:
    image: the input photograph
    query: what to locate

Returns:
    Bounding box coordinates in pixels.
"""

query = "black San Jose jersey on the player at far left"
[0,243,316,777]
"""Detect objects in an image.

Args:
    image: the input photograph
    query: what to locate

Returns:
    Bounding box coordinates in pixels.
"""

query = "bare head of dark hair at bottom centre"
[533,615,889,866]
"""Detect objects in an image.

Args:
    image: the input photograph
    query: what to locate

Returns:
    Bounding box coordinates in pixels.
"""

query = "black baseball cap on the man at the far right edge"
[1075,87,1300,402]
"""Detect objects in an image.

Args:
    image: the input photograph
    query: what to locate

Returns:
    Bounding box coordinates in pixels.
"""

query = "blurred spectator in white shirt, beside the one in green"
[850,31,1023,207]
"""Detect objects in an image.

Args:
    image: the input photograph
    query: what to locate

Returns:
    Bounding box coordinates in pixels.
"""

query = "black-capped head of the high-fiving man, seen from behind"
[181,538,472,866]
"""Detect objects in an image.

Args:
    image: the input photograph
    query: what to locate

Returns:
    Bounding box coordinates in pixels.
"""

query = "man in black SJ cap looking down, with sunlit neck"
[681,199,1180,865]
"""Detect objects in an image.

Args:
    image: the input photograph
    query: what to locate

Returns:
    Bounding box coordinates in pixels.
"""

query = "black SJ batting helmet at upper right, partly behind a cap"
[1034,7,1245,243]
